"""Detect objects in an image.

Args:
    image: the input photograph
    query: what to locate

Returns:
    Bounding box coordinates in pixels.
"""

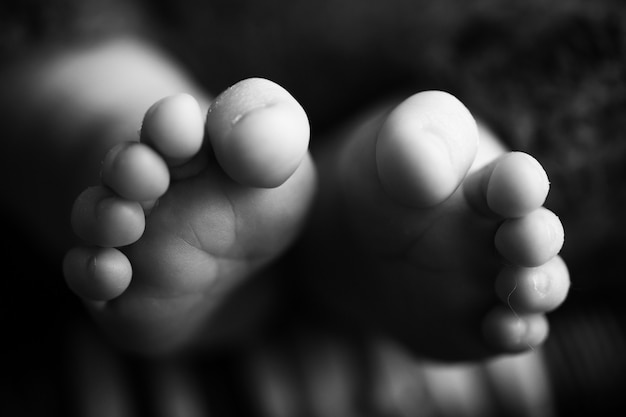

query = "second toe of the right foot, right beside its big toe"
[463,152,550,218]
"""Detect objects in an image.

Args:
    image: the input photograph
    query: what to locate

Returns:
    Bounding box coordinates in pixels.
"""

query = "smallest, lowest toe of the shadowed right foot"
[483,307,549,353]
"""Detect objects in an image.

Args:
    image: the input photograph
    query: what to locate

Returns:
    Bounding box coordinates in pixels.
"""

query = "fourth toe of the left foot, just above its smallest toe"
[71,186,145,247]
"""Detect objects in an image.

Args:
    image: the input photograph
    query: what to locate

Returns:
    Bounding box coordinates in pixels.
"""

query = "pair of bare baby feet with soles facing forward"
[64,79,569,357]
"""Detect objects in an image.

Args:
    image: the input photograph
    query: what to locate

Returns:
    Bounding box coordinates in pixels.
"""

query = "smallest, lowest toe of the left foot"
[63,247,132,301]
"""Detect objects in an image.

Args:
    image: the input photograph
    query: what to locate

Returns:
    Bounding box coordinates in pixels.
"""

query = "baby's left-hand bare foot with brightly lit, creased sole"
[64,79,316,353]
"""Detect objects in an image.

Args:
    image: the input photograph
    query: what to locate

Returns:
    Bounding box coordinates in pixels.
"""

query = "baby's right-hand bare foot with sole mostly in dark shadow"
[310,91,569,359]
